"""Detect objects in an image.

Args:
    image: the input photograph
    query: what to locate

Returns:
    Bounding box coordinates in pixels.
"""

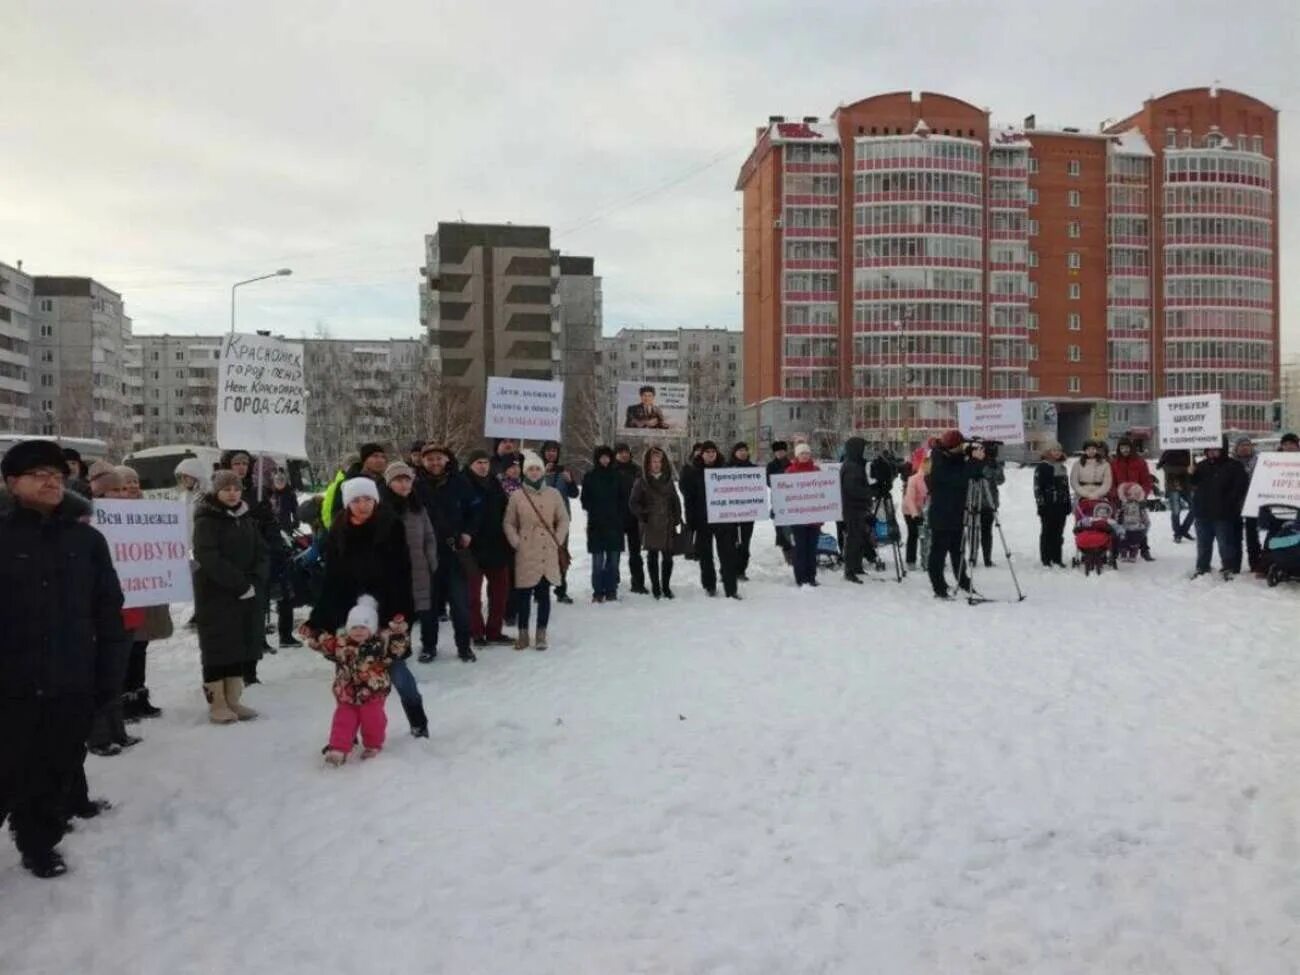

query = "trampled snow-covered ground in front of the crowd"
[0,472,1300,975]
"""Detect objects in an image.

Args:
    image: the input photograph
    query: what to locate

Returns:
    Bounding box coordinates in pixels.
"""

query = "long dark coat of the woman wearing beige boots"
[194,494,269,667]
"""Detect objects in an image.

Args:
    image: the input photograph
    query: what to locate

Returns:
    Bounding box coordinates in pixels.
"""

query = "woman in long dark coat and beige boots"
[194,471,268,724]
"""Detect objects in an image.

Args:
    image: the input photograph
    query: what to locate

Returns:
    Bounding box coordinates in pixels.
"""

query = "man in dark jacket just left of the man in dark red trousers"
[415,443,478,663]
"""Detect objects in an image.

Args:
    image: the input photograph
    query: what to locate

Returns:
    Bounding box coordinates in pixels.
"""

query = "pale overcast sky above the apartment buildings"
[0,0,1300,352]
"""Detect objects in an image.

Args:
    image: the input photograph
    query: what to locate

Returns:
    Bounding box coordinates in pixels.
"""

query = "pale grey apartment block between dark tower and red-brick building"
[599,328,754,459]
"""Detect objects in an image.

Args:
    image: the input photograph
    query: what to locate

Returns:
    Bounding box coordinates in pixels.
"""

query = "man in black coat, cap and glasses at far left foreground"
[0,441,130,878]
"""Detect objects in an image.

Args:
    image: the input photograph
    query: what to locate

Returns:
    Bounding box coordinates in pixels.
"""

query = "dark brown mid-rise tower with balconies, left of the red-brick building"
[420,224,602,441]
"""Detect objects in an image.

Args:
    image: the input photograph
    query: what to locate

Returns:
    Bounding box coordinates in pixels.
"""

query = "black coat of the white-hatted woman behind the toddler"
[307,506,415,633]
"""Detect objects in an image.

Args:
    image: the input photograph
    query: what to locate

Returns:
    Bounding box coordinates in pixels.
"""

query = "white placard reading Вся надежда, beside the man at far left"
[92,498,194,608]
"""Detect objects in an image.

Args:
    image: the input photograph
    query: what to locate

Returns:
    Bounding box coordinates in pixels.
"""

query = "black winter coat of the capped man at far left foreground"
[0,502,130,696]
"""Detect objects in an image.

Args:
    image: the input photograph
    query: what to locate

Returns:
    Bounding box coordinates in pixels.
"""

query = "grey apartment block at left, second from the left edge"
[31,277,134,451]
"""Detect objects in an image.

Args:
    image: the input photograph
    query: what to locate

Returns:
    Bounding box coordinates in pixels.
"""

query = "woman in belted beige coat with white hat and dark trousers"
[504,451,568,650]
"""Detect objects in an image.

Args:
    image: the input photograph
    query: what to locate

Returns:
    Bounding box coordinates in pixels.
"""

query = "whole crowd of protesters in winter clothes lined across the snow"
[0,430,1300,878]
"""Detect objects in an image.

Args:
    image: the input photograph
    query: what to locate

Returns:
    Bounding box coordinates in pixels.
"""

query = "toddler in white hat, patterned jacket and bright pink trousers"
[312,595,407,766]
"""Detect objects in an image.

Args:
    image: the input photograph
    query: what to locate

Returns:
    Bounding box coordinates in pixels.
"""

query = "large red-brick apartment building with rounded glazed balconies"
[736,88,1279,447]
